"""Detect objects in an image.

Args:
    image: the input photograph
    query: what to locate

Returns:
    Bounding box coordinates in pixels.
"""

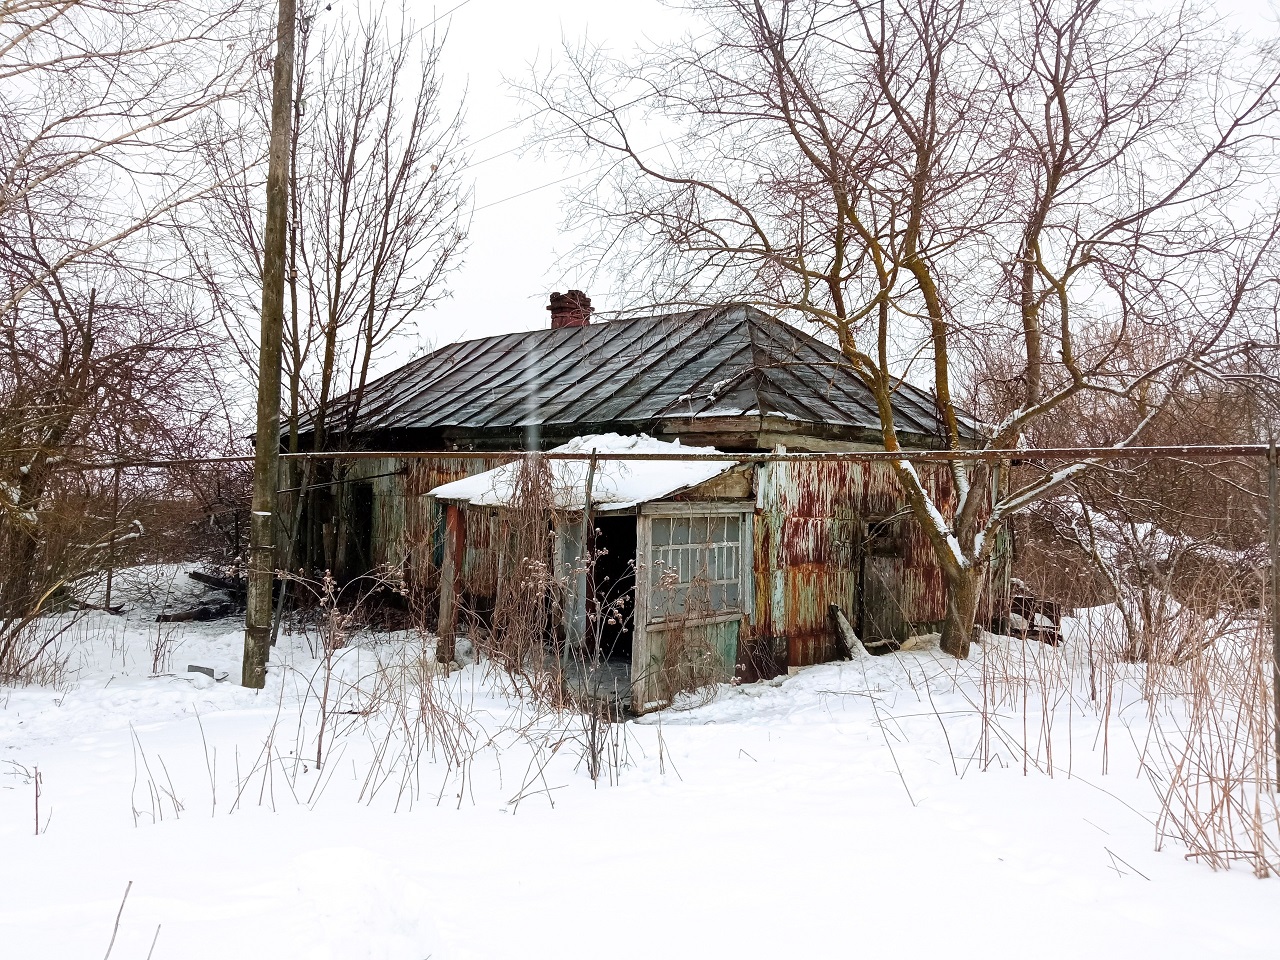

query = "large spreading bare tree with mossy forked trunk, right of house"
[526,0,1277,657]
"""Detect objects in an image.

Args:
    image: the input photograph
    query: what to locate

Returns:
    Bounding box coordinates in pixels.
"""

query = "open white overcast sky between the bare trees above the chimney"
[401,0,1275,355]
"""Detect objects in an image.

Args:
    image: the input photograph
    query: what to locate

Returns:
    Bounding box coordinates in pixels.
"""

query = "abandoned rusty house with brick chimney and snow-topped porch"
[296,291,1007,710]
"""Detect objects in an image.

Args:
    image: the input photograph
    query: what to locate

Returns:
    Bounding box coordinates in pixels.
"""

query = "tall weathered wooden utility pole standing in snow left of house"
[241,0,297,690]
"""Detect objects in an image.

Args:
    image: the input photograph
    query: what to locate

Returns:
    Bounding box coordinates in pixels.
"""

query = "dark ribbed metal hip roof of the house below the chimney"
[307,305,967,448]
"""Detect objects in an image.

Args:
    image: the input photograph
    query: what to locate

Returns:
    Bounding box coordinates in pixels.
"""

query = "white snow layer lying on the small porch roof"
[431,434,735,513]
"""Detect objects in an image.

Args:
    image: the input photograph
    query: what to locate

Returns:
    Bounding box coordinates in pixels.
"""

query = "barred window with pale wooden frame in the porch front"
[648,513,745,621]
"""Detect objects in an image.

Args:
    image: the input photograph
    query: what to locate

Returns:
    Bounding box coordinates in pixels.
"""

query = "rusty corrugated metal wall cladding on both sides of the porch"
[352,458,1007,680]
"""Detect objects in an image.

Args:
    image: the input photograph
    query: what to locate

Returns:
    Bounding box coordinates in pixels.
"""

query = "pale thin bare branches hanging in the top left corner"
[0,0,257,314]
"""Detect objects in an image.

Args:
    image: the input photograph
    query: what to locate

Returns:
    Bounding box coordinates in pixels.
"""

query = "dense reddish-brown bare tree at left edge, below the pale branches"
[0,252,224,677]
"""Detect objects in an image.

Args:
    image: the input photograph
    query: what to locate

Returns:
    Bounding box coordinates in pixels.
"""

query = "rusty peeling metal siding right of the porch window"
[754,462,951,667]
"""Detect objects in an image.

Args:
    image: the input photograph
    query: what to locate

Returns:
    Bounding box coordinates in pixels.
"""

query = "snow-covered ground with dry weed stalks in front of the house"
[0,568,1280,960]
